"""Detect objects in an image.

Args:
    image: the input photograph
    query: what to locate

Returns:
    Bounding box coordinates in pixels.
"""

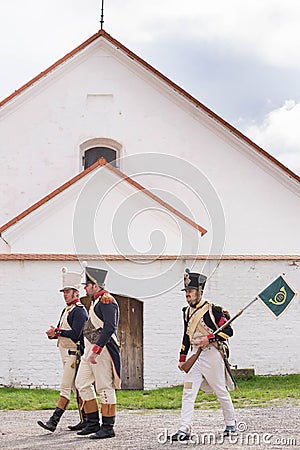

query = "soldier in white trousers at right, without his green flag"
[171,269,236,441]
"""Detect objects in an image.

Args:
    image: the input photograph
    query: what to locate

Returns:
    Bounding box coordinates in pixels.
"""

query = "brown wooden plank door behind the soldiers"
[112,294,144,389]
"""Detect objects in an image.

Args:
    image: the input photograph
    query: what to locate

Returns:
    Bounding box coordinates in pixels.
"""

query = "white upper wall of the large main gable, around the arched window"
[0,40,300,254]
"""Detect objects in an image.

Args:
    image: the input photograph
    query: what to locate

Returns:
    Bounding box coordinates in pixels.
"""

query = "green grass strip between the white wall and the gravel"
[0,374,300,410]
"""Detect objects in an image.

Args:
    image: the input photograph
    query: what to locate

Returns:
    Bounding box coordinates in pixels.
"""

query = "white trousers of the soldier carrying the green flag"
[179,345,235,433]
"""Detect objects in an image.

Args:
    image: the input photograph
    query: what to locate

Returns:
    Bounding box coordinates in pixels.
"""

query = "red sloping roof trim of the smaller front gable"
[0,158,207,236]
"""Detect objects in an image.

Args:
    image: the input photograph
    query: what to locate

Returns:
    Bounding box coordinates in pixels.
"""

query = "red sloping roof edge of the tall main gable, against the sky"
[0,30,300,182]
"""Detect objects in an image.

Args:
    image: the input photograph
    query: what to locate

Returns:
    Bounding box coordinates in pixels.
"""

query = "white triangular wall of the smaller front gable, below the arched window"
[2,167,201,255]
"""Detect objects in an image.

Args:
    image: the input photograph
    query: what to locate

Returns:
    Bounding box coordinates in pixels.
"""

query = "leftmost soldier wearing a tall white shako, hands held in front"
[37,268,88,432]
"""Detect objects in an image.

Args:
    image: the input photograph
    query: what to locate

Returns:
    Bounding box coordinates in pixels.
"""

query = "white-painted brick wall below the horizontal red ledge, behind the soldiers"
[0,261,300,389]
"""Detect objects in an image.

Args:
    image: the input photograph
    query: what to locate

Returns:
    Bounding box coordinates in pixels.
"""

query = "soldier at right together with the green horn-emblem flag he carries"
[171,270,297,441]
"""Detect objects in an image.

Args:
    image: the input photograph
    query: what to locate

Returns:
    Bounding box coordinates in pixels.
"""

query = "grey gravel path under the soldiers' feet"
[0,405,300,450]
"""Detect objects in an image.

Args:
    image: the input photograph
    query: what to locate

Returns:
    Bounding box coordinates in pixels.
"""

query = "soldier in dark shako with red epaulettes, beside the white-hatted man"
[75,267,121,439]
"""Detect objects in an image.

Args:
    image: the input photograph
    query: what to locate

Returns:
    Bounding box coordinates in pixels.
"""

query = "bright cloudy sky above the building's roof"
[0,0,300,174]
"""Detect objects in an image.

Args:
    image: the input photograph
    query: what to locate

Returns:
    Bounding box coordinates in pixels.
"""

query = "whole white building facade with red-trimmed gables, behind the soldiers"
[0,30,300,389]
